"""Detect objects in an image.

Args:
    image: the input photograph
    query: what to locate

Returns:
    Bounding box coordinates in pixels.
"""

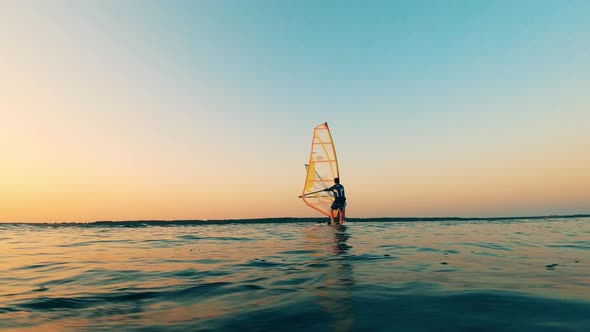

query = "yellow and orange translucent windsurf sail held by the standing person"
[301,123,339,216]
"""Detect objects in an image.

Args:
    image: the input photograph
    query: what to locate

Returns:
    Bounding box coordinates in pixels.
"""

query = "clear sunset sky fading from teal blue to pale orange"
[0,0,590,222]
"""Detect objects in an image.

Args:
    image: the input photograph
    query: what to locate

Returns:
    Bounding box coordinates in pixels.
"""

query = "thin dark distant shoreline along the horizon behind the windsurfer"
[0,214,590,226]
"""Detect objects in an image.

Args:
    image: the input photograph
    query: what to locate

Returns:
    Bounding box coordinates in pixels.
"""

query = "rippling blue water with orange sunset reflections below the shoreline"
[0,218,590,332]
